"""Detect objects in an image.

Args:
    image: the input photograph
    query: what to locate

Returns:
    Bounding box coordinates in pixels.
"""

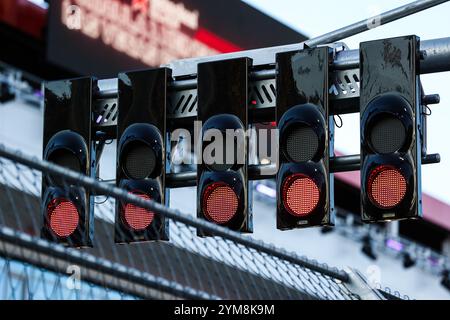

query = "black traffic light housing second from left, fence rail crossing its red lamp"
[115,68,171,243]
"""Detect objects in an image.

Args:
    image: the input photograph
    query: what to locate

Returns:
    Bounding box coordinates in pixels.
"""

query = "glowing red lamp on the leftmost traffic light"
[47,198,80,238]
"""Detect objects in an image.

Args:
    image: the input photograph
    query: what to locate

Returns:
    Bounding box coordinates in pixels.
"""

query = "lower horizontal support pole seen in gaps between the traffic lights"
[166,153,441,188]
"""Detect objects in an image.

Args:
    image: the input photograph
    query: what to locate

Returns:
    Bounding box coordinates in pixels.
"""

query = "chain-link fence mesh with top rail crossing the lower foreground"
[0,146,372,300]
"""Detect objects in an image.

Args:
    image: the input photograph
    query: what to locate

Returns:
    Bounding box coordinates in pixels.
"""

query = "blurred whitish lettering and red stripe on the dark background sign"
[60,0,240,66]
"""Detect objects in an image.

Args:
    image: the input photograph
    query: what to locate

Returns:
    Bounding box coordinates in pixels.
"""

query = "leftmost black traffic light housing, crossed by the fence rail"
[41,78,96,247]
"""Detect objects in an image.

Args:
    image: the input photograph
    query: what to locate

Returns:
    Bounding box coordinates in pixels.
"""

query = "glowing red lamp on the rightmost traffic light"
[367,165,407,209]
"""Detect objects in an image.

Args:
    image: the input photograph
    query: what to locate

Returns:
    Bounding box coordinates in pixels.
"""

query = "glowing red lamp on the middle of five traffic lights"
[203,182,239,224]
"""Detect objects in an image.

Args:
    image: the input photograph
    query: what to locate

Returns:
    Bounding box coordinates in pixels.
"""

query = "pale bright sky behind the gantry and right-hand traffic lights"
[244,0,450,204]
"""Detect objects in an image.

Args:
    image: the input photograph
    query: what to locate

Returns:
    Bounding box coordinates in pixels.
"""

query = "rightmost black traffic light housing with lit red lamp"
[360,36,422,222]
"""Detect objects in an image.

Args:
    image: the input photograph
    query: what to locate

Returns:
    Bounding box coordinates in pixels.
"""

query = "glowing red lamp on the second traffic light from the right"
[283,174,320,217]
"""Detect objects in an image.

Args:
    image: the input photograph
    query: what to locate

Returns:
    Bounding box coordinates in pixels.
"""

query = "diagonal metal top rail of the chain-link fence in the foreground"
[0,144,349,283]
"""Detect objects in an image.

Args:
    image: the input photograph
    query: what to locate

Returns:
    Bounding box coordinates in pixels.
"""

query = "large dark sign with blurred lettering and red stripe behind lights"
[47,0,305,77]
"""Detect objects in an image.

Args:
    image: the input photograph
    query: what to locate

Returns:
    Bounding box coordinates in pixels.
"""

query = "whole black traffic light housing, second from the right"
[276,47,334,230]
